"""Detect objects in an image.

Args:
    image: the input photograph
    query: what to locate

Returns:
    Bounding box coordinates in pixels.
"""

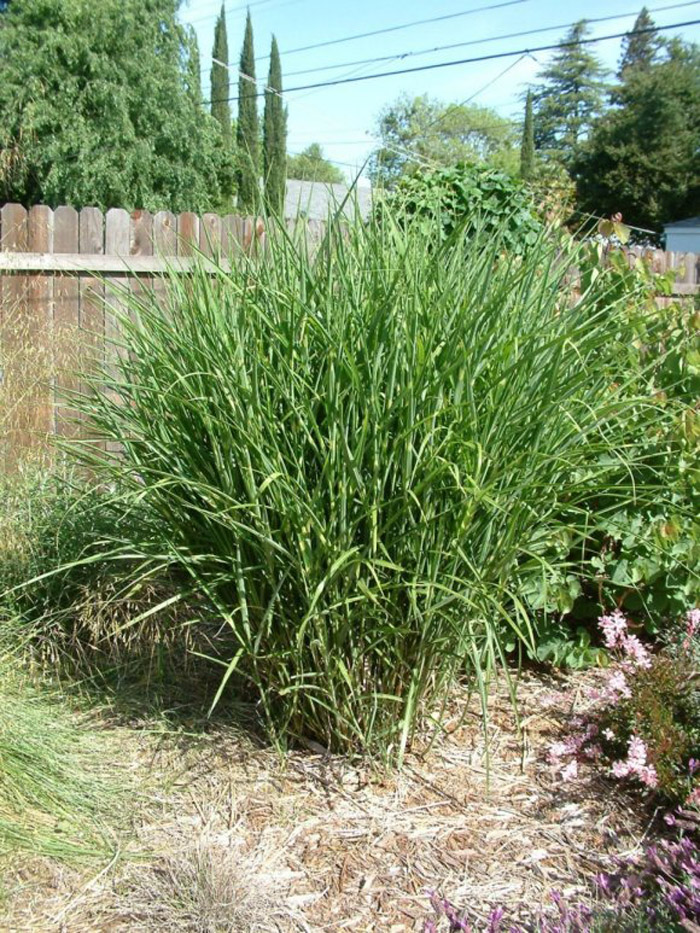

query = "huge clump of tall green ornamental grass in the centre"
[72,217,672,760]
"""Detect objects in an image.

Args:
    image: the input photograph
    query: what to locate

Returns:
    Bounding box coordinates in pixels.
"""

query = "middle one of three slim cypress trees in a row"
[236,10,260,213]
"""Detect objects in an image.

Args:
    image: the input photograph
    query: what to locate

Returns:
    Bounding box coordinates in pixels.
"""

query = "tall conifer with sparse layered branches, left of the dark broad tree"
[533,20,606,165]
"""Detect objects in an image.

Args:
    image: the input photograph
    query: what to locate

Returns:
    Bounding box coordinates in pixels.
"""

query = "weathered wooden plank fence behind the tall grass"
[0,204,700,465]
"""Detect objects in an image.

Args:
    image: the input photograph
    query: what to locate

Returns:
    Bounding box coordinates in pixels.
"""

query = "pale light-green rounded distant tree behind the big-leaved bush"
[370,95,518,187]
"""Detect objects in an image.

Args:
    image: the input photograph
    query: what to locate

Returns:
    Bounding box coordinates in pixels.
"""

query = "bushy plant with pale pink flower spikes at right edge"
[548,609,700,806]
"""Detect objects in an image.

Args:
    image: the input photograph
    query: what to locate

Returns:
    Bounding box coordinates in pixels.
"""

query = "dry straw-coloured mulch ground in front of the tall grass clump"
[0,675,649,933]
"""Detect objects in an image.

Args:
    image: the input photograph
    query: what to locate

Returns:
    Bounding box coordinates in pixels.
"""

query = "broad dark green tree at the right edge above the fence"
[575,39,700,232]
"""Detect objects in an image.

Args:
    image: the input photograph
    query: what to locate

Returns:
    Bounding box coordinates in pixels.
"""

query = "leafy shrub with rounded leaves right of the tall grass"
[582,252,700,629]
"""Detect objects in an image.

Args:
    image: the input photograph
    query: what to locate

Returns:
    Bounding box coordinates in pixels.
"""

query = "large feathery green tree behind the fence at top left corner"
[0,0,233,211]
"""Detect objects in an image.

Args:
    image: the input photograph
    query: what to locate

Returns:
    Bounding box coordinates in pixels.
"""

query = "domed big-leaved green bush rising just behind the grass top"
[380,164,542,253]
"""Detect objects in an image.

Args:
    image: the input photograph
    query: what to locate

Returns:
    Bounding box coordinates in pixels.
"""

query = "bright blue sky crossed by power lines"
[180,0,700,184]
